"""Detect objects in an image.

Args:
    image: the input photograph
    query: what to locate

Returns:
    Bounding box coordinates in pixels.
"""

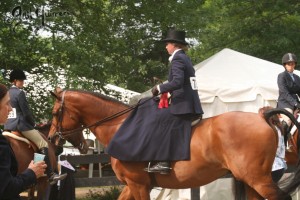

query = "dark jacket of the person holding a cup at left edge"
[0,135,36,199]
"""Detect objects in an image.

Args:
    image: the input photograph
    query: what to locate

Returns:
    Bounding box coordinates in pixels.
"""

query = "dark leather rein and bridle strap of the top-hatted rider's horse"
[52,91,156,140]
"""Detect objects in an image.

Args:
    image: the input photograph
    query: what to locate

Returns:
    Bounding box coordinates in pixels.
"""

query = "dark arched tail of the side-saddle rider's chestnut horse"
[263,108,300,198]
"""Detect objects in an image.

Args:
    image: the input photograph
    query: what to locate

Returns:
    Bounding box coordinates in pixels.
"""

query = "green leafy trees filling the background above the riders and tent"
[0,0,300,122]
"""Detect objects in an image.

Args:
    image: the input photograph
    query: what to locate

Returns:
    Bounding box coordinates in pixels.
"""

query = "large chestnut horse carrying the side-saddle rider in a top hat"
[49,90,300,200]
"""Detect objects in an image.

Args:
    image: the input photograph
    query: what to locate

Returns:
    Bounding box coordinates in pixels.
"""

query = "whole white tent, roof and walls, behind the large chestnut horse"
[142,49,300,200]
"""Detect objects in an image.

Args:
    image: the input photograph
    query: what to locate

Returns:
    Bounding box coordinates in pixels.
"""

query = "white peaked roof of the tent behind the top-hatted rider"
[194,49,298,103]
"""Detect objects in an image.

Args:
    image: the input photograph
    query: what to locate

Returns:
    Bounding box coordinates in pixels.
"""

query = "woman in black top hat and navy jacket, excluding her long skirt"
[149,30,203,173]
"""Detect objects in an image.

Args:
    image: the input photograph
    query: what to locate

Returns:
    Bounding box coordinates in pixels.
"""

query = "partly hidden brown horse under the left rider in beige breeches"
[3,132,57,200]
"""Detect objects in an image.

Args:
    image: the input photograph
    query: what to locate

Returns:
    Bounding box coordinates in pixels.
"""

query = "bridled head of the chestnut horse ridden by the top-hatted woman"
[48,88,89,154]
